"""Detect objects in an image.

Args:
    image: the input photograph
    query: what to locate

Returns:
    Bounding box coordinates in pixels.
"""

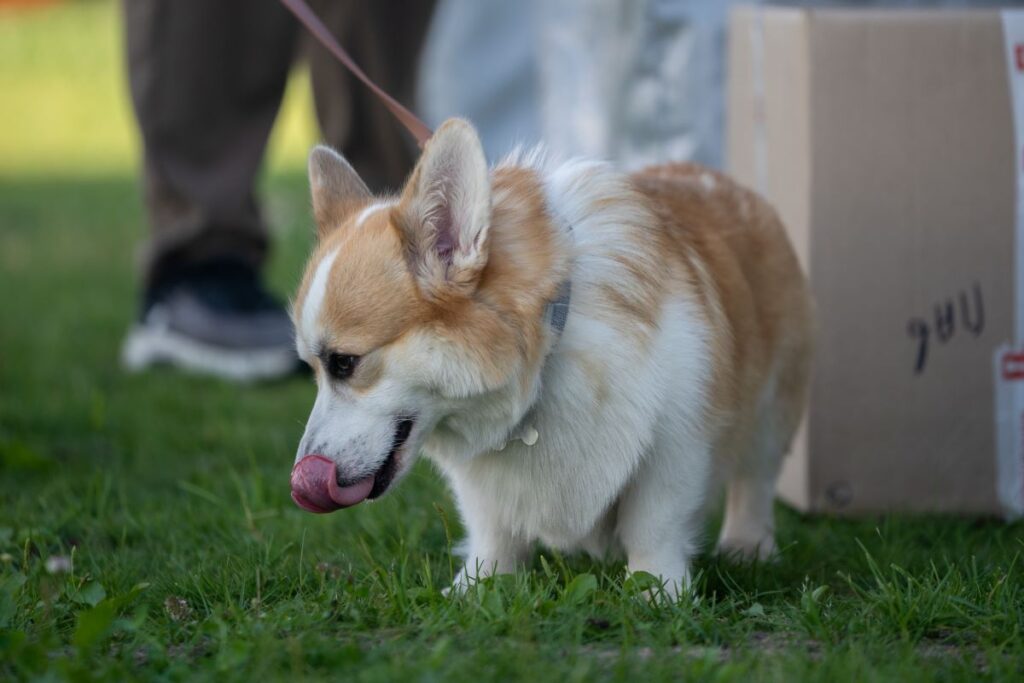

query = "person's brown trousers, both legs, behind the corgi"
[125,0,433,283]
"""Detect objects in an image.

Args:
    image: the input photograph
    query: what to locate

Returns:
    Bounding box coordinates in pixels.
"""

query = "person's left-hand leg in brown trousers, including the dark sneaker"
[124,0,297,379]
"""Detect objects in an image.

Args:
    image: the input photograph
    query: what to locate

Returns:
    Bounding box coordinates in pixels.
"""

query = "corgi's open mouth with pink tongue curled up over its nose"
[292,418,416,514]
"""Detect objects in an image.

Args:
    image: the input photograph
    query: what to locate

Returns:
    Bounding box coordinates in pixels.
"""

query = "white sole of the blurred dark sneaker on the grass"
[121,326,298,382]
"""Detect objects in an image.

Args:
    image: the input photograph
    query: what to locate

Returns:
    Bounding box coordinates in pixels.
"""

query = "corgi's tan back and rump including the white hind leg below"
[633,164,812,556]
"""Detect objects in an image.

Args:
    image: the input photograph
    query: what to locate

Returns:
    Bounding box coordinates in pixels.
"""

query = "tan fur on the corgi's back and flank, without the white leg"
[633,164,812,456]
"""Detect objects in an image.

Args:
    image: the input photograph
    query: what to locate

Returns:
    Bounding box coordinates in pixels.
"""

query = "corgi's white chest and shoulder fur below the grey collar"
[427,301,709,553]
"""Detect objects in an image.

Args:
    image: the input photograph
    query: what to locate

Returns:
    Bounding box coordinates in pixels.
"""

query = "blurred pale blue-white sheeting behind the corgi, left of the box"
[419,0,736,169]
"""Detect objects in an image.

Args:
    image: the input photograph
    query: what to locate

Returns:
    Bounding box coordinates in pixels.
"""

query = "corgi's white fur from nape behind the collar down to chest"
[425,158,711,570]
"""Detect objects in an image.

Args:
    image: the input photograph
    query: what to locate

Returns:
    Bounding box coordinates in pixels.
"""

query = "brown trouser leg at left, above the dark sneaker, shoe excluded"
[125,0,296,276]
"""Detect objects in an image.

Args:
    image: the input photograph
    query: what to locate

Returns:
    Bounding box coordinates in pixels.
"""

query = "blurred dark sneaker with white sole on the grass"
[121,260,299,382]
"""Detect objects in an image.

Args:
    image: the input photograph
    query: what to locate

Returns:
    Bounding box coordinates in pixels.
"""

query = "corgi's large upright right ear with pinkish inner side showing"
[396,119,490,296]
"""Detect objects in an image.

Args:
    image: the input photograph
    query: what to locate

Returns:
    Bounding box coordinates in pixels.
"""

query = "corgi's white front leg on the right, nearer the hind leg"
[616,434,711,599]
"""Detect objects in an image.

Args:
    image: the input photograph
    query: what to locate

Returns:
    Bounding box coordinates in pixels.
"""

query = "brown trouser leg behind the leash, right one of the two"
[305,0,434,193]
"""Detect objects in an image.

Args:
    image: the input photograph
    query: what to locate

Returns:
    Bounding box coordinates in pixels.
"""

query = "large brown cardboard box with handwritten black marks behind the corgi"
[728,8,1024,515]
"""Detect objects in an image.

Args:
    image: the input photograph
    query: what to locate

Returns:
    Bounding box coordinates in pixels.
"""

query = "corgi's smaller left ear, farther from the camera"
[309,144,372,239]
